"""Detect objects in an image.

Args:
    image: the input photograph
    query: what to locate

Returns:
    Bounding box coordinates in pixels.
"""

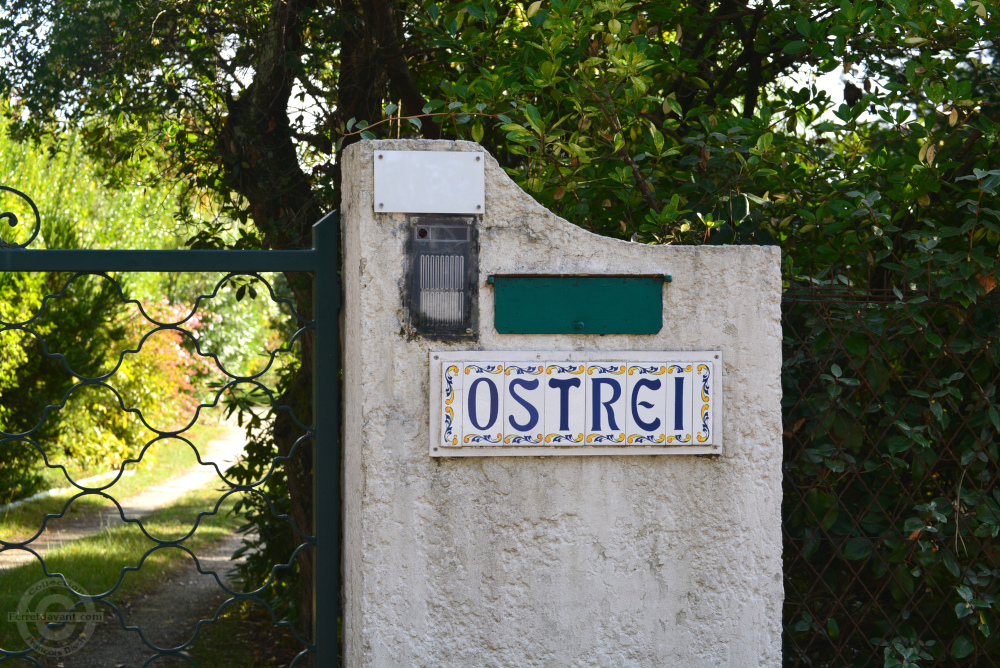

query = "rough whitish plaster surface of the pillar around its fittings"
[343,140,782,667]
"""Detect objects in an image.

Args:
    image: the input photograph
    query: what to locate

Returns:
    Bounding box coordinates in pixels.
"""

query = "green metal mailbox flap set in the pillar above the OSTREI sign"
[491,274,664,334]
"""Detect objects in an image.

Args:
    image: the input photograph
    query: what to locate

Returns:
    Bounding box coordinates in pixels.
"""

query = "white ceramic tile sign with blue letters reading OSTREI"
[430,351,722,457]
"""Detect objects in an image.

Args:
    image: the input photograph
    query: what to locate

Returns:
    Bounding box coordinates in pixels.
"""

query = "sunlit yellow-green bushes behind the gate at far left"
[0,126,230,503]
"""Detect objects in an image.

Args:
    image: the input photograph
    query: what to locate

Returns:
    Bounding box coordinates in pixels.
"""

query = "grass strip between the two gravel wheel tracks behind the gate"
[0,484,239,652]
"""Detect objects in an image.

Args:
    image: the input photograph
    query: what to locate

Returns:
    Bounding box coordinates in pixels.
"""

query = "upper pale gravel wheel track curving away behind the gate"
[0,428,245,573]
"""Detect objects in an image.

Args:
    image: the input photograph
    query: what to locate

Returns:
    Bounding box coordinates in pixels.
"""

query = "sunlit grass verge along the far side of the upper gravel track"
[0,425,226,541]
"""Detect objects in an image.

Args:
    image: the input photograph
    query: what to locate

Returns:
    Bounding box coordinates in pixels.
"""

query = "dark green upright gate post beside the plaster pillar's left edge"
[313,211,341,668]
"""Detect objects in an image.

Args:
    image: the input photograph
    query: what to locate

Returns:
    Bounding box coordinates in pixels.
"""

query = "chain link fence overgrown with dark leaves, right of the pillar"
[782,281,1000,666]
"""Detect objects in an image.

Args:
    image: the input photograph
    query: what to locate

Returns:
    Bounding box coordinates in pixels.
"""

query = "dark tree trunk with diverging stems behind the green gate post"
[218,0,440,639]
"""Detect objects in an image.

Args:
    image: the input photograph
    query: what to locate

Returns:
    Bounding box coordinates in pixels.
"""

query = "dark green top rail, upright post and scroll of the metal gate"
[0,185,342,666]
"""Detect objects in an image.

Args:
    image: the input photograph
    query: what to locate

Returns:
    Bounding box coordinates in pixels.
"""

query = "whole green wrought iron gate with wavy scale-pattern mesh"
[0,186,341,666]
